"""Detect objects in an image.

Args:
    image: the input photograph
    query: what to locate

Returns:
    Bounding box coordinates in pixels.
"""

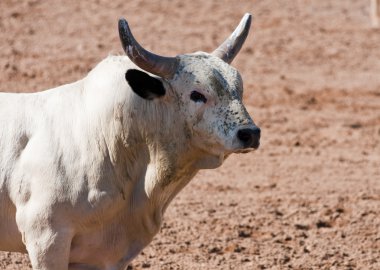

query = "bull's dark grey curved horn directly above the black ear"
[119,18,178,79]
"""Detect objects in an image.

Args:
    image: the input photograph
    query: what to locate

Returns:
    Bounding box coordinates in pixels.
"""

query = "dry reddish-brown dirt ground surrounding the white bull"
[0,0,380,269]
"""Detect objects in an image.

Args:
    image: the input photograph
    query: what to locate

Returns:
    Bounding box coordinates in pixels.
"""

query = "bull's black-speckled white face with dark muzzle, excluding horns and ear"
[171,53,260,157]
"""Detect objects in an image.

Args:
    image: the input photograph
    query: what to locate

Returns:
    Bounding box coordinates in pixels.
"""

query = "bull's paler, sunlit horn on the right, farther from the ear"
[212,13,252,64]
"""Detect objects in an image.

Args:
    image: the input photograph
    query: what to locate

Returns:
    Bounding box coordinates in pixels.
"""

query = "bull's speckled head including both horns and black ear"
[119,14,260,167]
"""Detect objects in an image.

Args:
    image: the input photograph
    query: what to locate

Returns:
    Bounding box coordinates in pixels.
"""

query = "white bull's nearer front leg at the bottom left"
[17,207,73,270]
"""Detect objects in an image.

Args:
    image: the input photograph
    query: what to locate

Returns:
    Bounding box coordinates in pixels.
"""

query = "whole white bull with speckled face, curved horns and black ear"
[0,14,260,270]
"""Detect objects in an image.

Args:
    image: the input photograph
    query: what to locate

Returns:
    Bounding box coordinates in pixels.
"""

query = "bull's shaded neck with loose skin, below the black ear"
[102,91,198,231]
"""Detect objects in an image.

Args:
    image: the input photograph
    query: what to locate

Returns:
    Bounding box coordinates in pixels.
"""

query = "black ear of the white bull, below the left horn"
[125,69,165,100]
